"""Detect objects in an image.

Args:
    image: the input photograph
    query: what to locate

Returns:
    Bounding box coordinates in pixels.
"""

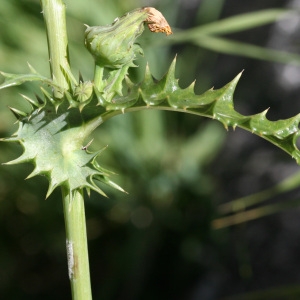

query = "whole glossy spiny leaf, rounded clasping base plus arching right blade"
[3,60,300,200]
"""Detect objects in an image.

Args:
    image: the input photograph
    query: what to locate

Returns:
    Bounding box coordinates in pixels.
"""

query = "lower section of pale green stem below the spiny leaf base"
[62,189,92,300]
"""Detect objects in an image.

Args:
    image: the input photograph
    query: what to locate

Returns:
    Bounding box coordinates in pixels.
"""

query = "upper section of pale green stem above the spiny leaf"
[41,0,71,98]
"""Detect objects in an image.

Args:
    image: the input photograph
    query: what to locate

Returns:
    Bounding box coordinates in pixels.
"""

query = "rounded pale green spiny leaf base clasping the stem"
[4,96,123,198]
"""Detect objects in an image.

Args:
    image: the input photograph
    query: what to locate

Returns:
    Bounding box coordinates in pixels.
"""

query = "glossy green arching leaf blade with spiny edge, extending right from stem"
[100,60,300,164]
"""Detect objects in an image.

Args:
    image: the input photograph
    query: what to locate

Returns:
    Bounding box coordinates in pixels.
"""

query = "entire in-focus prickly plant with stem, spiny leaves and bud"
[0,0,300,299]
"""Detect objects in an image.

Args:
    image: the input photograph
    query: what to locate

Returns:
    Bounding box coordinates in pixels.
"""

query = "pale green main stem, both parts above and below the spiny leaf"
[41,0,92,300]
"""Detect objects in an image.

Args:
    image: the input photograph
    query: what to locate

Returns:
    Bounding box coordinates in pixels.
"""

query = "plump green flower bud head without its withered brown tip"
[85,8,148,69]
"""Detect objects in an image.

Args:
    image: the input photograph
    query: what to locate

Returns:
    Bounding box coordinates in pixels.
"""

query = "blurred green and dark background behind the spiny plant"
[0,0,300,300]
